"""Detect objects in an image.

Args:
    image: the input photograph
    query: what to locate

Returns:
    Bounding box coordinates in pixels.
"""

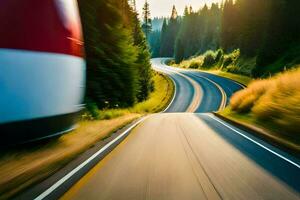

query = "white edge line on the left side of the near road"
[35,117,147,200]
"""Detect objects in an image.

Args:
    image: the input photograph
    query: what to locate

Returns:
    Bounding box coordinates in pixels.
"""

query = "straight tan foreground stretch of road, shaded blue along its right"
[62,113,300,200]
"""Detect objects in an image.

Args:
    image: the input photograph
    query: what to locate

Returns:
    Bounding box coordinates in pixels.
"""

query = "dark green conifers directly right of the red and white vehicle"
[79,0,152,108]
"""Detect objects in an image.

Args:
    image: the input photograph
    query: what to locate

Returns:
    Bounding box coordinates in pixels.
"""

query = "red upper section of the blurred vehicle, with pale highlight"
[0,0,84,57]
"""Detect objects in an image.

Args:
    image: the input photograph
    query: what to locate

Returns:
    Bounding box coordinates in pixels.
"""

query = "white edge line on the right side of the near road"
[207,115,300,169]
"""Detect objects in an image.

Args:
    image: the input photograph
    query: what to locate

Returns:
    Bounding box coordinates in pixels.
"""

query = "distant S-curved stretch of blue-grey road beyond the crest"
[152,58,244,113]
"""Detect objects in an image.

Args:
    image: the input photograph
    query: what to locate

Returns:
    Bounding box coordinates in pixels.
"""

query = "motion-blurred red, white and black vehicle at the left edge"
[0,0,85,143]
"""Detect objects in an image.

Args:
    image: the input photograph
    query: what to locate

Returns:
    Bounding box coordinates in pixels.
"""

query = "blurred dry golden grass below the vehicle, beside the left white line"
[0,114,140,199]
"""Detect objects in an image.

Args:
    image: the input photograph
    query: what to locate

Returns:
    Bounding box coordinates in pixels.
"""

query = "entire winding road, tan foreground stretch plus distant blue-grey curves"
[40,59,300,200]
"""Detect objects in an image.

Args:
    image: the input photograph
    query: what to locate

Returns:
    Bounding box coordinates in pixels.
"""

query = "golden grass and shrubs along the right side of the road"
[170,50,300,151]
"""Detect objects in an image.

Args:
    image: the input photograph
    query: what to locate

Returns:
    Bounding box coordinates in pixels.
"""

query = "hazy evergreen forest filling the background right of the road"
[150,0,300,77]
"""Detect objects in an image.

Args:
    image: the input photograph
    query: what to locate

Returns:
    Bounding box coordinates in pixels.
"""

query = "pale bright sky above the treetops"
[136,0,221,17]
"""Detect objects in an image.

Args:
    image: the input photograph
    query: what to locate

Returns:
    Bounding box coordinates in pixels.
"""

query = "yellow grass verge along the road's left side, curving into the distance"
[0,73,174,199]
